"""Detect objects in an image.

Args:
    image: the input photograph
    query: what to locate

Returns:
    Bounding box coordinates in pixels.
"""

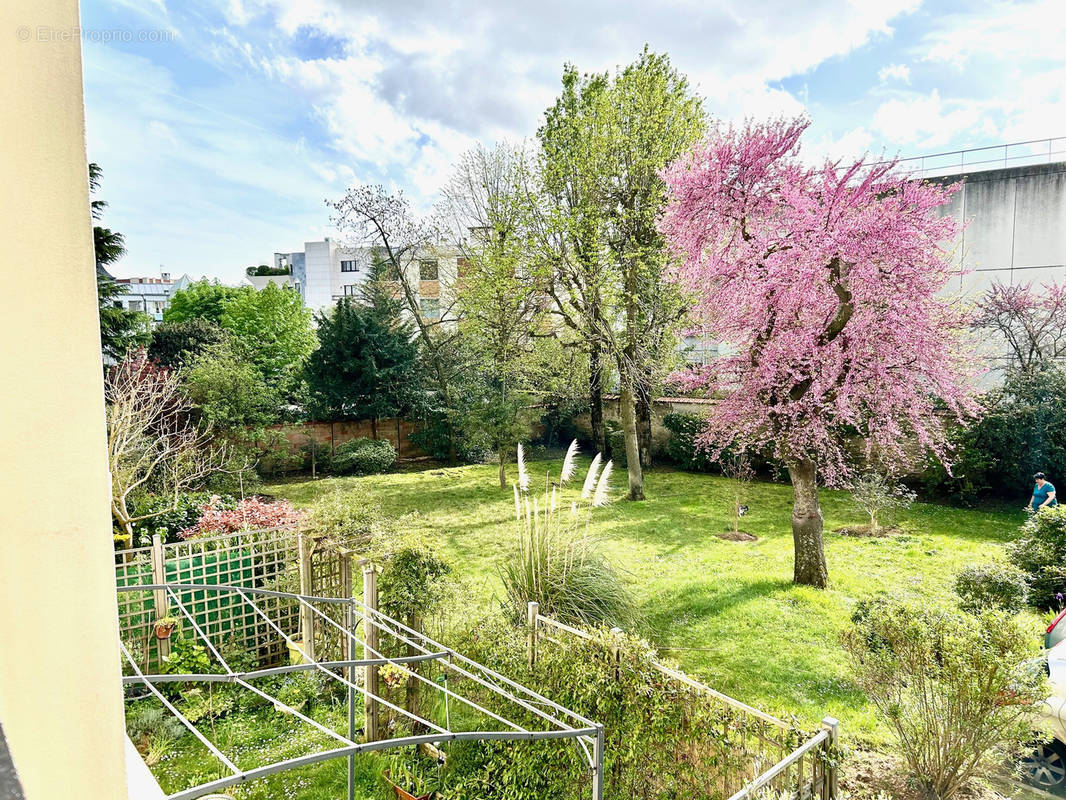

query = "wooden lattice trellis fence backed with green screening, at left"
[115,528,354,670]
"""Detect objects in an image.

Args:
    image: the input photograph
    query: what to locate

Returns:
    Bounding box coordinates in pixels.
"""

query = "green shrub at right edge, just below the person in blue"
[1007,505,1066,608]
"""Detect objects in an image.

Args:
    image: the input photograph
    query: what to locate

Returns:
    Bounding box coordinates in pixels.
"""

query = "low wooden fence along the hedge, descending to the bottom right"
[527,603,840,800]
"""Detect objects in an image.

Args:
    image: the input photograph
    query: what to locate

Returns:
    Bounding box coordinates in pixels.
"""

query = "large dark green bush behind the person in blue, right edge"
[924,365,1066,505]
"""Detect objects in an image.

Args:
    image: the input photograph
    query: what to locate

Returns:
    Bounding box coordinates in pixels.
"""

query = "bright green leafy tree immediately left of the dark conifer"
[222,284,316,395]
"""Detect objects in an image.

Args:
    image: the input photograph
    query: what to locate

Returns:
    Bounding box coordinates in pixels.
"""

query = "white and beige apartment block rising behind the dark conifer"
[274,237,459,323]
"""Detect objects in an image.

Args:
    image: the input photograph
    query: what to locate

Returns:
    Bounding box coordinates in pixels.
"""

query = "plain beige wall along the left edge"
[0,0,126,800]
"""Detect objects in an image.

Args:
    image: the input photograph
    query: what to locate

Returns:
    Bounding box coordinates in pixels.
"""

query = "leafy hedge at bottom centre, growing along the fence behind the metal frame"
[446,619,750,800]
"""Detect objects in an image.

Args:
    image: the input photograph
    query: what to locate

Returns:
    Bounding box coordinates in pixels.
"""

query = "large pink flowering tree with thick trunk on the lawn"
[662,119,974,588]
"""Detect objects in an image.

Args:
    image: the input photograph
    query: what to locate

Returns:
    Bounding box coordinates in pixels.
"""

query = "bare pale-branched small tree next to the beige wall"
[104,349,225,543]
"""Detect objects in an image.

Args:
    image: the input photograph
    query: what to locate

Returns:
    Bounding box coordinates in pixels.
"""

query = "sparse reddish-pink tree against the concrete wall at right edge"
[973,283,1066,372]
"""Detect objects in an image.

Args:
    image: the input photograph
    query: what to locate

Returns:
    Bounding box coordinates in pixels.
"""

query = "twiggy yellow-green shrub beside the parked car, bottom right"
[843,599,1045,800]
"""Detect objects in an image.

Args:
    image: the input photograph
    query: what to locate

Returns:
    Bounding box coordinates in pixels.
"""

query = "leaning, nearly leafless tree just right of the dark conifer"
[332,186,464,463]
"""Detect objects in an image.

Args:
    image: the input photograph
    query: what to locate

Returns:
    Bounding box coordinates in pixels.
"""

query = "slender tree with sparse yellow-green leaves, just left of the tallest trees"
[440,144,547,489]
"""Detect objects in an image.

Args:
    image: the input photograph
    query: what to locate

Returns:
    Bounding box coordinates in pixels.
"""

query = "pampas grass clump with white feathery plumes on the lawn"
[500,442,639,628]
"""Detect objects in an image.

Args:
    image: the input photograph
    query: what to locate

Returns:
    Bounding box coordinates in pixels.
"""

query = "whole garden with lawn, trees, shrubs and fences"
[94,49,1066,800]
